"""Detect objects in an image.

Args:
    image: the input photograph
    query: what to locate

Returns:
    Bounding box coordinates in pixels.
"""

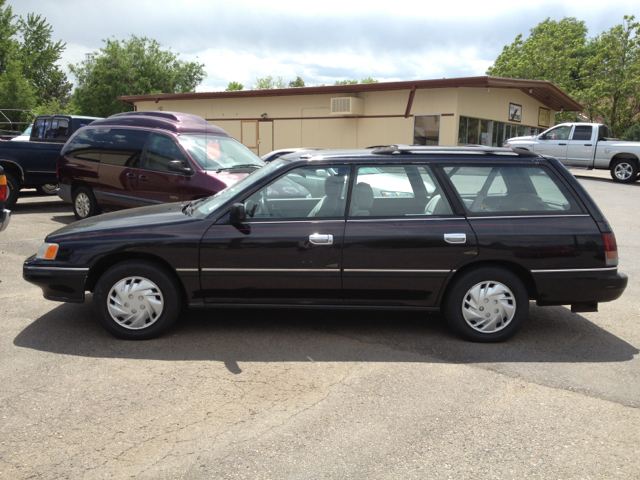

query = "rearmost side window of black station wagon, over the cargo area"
[444,165,582,215]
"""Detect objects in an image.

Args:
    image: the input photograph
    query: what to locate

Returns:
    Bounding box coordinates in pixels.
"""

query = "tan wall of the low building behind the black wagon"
[137,88,555,150]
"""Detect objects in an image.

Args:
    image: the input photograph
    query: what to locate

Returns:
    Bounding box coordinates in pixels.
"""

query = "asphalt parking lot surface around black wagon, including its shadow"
[0,171,640,480]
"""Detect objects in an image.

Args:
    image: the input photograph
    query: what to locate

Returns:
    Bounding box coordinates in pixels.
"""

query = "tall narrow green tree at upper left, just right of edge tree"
[18,13,72,104]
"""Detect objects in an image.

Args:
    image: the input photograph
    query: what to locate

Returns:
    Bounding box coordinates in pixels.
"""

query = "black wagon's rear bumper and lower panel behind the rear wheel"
[532,267,628,306]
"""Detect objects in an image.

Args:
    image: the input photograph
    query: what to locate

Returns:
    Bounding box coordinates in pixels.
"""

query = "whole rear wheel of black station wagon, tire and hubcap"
[443,267,529,343]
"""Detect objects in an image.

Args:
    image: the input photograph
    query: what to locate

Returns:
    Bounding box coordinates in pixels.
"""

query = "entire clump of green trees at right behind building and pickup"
[487,16,640,136]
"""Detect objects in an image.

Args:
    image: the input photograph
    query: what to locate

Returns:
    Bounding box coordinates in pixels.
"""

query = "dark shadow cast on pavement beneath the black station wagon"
[14,295,640,373]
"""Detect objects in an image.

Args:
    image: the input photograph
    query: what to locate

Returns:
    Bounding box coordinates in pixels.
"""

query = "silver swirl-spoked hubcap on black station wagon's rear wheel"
[462,281,516,333]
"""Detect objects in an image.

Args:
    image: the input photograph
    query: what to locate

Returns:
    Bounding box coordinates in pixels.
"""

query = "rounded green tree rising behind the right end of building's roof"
[487,17,587,93]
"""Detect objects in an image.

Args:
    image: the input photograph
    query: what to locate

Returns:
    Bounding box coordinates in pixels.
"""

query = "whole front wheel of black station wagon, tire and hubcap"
[93,260,181,340]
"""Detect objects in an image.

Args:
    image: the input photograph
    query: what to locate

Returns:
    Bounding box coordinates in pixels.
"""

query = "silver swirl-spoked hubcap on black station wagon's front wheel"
[107,277,164,330]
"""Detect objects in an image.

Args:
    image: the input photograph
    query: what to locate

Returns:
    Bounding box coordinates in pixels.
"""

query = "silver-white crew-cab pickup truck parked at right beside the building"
[503,123,640,183]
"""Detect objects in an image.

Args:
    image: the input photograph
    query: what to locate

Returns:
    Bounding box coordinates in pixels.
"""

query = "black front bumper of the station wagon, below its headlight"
[22,257,89,303]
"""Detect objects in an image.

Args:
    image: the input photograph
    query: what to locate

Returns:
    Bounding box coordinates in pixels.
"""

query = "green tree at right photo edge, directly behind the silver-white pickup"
[579,15,640,137]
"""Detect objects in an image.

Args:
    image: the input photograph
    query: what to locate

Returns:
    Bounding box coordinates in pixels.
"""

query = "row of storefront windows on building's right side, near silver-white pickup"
[458,116,542,147]
